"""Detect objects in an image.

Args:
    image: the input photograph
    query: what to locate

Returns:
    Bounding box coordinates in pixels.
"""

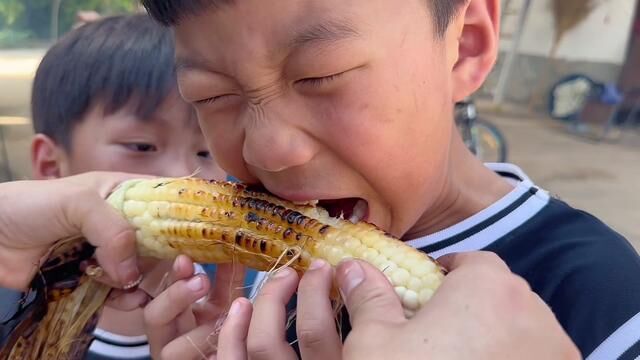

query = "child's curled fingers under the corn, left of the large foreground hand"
[144,256,245,359]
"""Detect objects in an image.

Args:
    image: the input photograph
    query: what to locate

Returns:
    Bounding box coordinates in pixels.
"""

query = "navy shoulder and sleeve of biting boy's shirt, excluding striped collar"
[489,200,640,360]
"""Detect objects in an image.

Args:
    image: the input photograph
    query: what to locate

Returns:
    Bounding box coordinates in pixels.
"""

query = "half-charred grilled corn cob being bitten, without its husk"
[108,178,444,315]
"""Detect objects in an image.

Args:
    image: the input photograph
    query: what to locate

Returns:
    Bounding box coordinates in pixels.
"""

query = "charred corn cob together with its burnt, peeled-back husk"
[0,178,444,360]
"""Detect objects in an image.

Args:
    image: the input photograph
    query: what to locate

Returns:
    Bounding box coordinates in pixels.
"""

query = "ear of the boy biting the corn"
[446,0,500,102]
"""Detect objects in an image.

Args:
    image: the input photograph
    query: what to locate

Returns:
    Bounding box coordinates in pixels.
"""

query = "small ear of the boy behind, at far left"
[31,134,66,180]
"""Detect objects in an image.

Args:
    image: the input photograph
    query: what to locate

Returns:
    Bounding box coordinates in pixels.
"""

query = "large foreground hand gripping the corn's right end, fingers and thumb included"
[217,253,580,360]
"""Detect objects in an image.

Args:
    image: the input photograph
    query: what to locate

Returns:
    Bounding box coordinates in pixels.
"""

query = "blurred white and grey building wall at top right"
[481,0,636,110]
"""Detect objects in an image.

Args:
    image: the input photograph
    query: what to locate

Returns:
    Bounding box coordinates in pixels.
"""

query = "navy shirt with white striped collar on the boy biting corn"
[409,164,640,360]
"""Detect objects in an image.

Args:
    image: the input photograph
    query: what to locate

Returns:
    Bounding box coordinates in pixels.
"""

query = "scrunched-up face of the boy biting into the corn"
[176,0,470,236]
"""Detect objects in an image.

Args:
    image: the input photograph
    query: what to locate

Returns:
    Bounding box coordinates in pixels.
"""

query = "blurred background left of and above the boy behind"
[0,0,142,182]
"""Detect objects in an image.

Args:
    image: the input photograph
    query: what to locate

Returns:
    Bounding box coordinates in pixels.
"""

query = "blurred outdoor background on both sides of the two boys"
[0,0,640,249]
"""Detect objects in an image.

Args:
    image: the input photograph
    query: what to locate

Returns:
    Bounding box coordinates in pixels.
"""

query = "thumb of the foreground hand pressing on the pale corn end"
[336,260,405,328]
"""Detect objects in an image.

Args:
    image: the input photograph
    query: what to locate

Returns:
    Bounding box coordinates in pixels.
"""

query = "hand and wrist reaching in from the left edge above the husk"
[0,172,144,289]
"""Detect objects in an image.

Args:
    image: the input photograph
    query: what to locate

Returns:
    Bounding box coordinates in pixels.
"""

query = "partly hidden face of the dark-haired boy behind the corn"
[61,94,224,179]
